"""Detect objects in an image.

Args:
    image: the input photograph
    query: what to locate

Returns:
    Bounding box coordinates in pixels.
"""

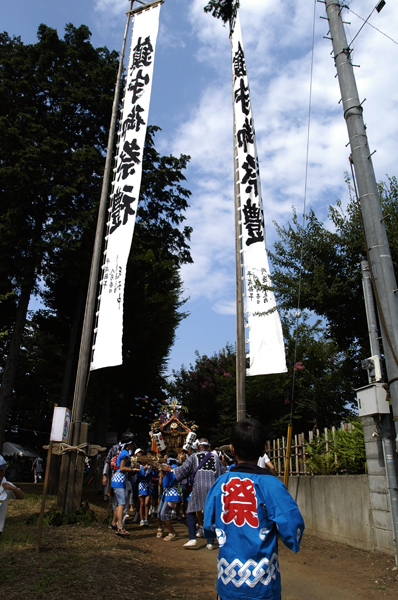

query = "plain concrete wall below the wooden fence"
[289,475,374,550]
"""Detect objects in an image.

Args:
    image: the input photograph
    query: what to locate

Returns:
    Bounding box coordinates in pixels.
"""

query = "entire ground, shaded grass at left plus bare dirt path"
[0,484,398,600]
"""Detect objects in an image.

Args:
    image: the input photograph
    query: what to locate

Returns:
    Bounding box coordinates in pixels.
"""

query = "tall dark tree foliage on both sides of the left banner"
[0,25,192,445]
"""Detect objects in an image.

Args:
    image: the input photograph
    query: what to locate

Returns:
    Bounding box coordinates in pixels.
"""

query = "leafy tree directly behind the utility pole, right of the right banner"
[270,177,398,356]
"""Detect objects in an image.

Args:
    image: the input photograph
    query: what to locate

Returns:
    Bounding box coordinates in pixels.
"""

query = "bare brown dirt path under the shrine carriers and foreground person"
[123,523,398,600]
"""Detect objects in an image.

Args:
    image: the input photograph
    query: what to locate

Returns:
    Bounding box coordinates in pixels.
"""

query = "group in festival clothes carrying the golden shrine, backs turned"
[102,431,227,549]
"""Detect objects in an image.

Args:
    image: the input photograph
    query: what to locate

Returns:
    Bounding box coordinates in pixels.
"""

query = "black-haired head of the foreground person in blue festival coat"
[231,419,267,462]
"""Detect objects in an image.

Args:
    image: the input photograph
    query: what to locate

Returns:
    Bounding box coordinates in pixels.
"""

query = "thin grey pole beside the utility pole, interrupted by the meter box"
[361,260,398,564]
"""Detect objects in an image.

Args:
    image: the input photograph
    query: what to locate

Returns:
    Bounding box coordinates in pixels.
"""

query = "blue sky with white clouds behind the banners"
[0,0,398,370]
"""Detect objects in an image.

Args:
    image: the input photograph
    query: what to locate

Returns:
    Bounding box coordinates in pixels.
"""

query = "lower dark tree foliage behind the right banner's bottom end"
[169,319,362,444]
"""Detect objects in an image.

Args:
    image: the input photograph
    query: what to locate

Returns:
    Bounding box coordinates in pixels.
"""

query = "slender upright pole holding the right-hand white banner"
[230,21,246,421]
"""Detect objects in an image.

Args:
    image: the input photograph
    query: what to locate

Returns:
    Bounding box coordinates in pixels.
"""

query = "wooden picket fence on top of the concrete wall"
[267,423,353,475]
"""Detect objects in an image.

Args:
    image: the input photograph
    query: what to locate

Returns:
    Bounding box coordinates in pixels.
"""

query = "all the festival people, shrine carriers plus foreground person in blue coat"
[102,419,304,600]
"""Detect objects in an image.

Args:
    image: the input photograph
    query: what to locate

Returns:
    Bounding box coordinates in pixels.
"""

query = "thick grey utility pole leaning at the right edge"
[325,0,398,449]
